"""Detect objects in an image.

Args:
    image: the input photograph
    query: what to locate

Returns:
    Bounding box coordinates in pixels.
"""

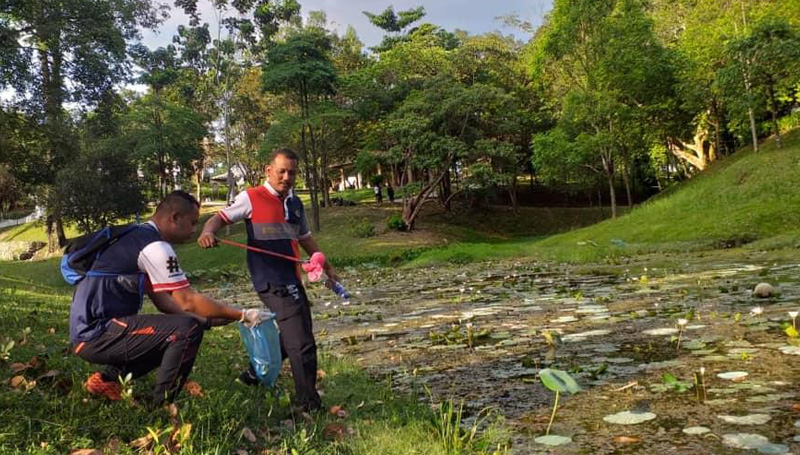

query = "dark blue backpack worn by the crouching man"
[61,224,139,285]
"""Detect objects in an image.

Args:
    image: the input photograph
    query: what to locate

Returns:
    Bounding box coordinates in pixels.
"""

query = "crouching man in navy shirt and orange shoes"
[69,191,260,407]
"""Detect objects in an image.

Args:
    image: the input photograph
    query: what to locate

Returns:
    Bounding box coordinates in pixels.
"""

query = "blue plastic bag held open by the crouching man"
[239,312,281,387]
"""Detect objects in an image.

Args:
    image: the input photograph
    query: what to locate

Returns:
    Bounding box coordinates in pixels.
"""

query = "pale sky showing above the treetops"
[142,0,553,48]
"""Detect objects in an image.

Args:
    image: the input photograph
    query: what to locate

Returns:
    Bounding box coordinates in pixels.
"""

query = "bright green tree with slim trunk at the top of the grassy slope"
[534,0,671,216]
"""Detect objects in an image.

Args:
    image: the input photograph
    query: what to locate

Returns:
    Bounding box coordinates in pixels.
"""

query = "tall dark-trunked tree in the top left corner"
[0,0,164,251]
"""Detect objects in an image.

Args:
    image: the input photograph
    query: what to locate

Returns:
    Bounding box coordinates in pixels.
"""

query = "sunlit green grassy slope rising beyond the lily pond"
[411,130,800,266]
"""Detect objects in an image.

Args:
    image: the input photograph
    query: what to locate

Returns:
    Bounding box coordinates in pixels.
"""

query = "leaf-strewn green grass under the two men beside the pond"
[0,284,506,455]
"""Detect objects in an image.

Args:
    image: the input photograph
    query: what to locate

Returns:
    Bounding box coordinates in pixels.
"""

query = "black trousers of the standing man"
[251,285,322,410]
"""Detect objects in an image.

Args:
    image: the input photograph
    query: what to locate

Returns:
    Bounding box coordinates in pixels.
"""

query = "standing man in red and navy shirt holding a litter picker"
[197,149,338,411]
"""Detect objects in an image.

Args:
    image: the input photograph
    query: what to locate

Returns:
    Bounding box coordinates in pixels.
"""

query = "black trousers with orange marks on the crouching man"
[75,314,203,405]
